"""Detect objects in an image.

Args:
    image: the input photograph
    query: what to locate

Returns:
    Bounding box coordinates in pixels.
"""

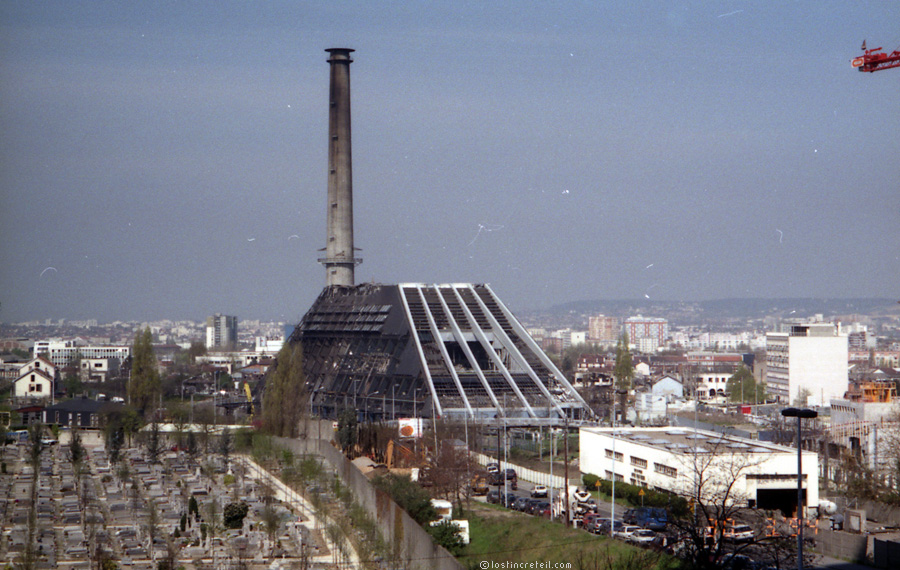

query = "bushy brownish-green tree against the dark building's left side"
[262,342,306,437]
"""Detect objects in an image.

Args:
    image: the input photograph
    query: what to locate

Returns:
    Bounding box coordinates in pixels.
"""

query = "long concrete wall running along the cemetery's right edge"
[275,438,464,570]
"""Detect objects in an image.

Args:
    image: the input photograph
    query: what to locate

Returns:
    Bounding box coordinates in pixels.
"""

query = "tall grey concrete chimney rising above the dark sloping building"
[319,48,362,287]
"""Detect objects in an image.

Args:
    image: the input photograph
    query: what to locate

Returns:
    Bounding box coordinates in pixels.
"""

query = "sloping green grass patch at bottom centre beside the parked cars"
[459,503,677,570]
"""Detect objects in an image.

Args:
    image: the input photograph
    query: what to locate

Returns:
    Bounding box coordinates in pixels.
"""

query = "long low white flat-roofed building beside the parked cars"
[579,427,819,514]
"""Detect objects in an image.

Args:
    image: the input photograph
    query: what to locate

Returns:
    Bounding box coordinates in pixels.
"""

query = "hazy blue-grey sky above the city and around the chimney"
[0,0,900,322]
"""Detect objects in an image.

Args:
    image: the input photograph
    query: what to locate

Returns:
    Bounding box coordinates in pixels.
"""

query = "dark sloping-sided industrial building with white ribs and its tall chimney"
[270,48,591,425]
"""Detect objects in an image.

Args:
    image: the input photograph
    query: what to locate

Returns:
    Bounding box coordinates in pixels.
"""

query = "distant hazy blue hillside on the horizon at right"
[522,298,900,325]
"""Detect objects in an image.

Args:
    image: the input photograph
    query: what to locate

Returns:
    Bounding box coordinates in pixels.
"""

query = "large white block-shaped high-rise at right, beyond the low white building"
[766,323,849,406]
